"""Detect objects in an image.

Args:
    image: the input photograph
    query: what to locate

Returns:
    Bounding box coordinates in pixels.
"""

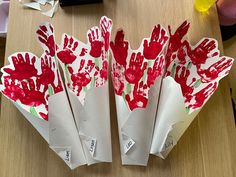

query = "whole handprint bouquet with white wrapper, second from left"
[57,17,112,164]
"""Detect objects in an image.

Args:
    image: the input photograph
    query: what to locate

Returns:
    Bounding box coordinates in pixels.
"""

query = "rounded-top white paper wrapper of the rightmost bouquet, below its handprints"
[150,76,200,158]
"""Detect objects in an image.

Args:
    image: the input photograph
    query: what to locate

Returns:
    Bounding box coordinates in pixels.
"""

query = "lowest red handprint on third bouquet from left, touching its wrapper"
[125,81,148,111]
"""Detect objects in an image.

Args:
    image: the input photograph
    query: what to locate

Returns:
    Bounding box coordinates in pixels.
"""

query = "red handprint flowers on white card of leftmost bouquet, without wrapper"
[1,23,63,120]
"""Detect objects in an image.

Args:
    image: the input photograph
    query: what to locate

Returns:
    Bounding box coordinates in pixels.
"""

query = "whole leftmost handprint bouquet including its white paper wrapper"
[1,23,86,169]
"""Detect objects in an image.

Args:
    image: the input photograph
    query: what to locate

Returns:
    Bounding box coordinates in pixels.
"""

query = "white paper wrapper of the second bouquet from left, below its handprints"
[68,84,112,165]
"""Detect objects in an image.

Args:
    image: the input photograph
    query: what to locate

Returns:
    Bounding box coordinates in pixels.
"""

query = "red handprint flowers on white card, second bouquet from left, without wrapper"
[57,17,112,104]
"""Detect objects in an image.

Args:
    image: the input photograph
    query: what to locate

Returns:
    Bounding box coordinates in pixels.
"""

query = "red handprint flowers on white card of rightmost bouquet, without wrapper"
[165,22,233,113]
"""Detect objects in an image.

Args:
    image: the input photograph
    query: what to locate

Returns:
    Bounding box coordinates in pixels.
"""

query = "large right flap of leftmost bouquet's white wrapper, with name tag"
[48,91,86,169]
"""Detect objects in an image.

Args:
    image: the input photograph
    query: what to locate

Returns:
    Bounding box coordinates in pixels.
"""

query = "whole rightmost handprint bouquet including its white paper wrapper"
[150,22,233,158]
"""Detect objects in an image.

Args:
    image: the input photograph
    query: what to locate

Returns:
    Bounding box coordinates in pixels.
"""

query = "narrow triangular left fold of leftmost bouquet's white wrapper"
[13,102,49,143]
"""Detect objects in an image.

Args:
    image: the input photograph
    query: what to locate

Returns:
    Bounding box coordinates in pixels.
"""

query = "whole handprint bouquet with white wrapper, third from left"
[110,25,168,166]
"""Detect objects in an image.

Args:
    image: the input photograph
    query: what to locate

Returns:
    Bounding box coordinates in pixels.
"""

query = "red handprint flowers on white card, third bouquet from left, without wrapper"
[110,25,168,111]
